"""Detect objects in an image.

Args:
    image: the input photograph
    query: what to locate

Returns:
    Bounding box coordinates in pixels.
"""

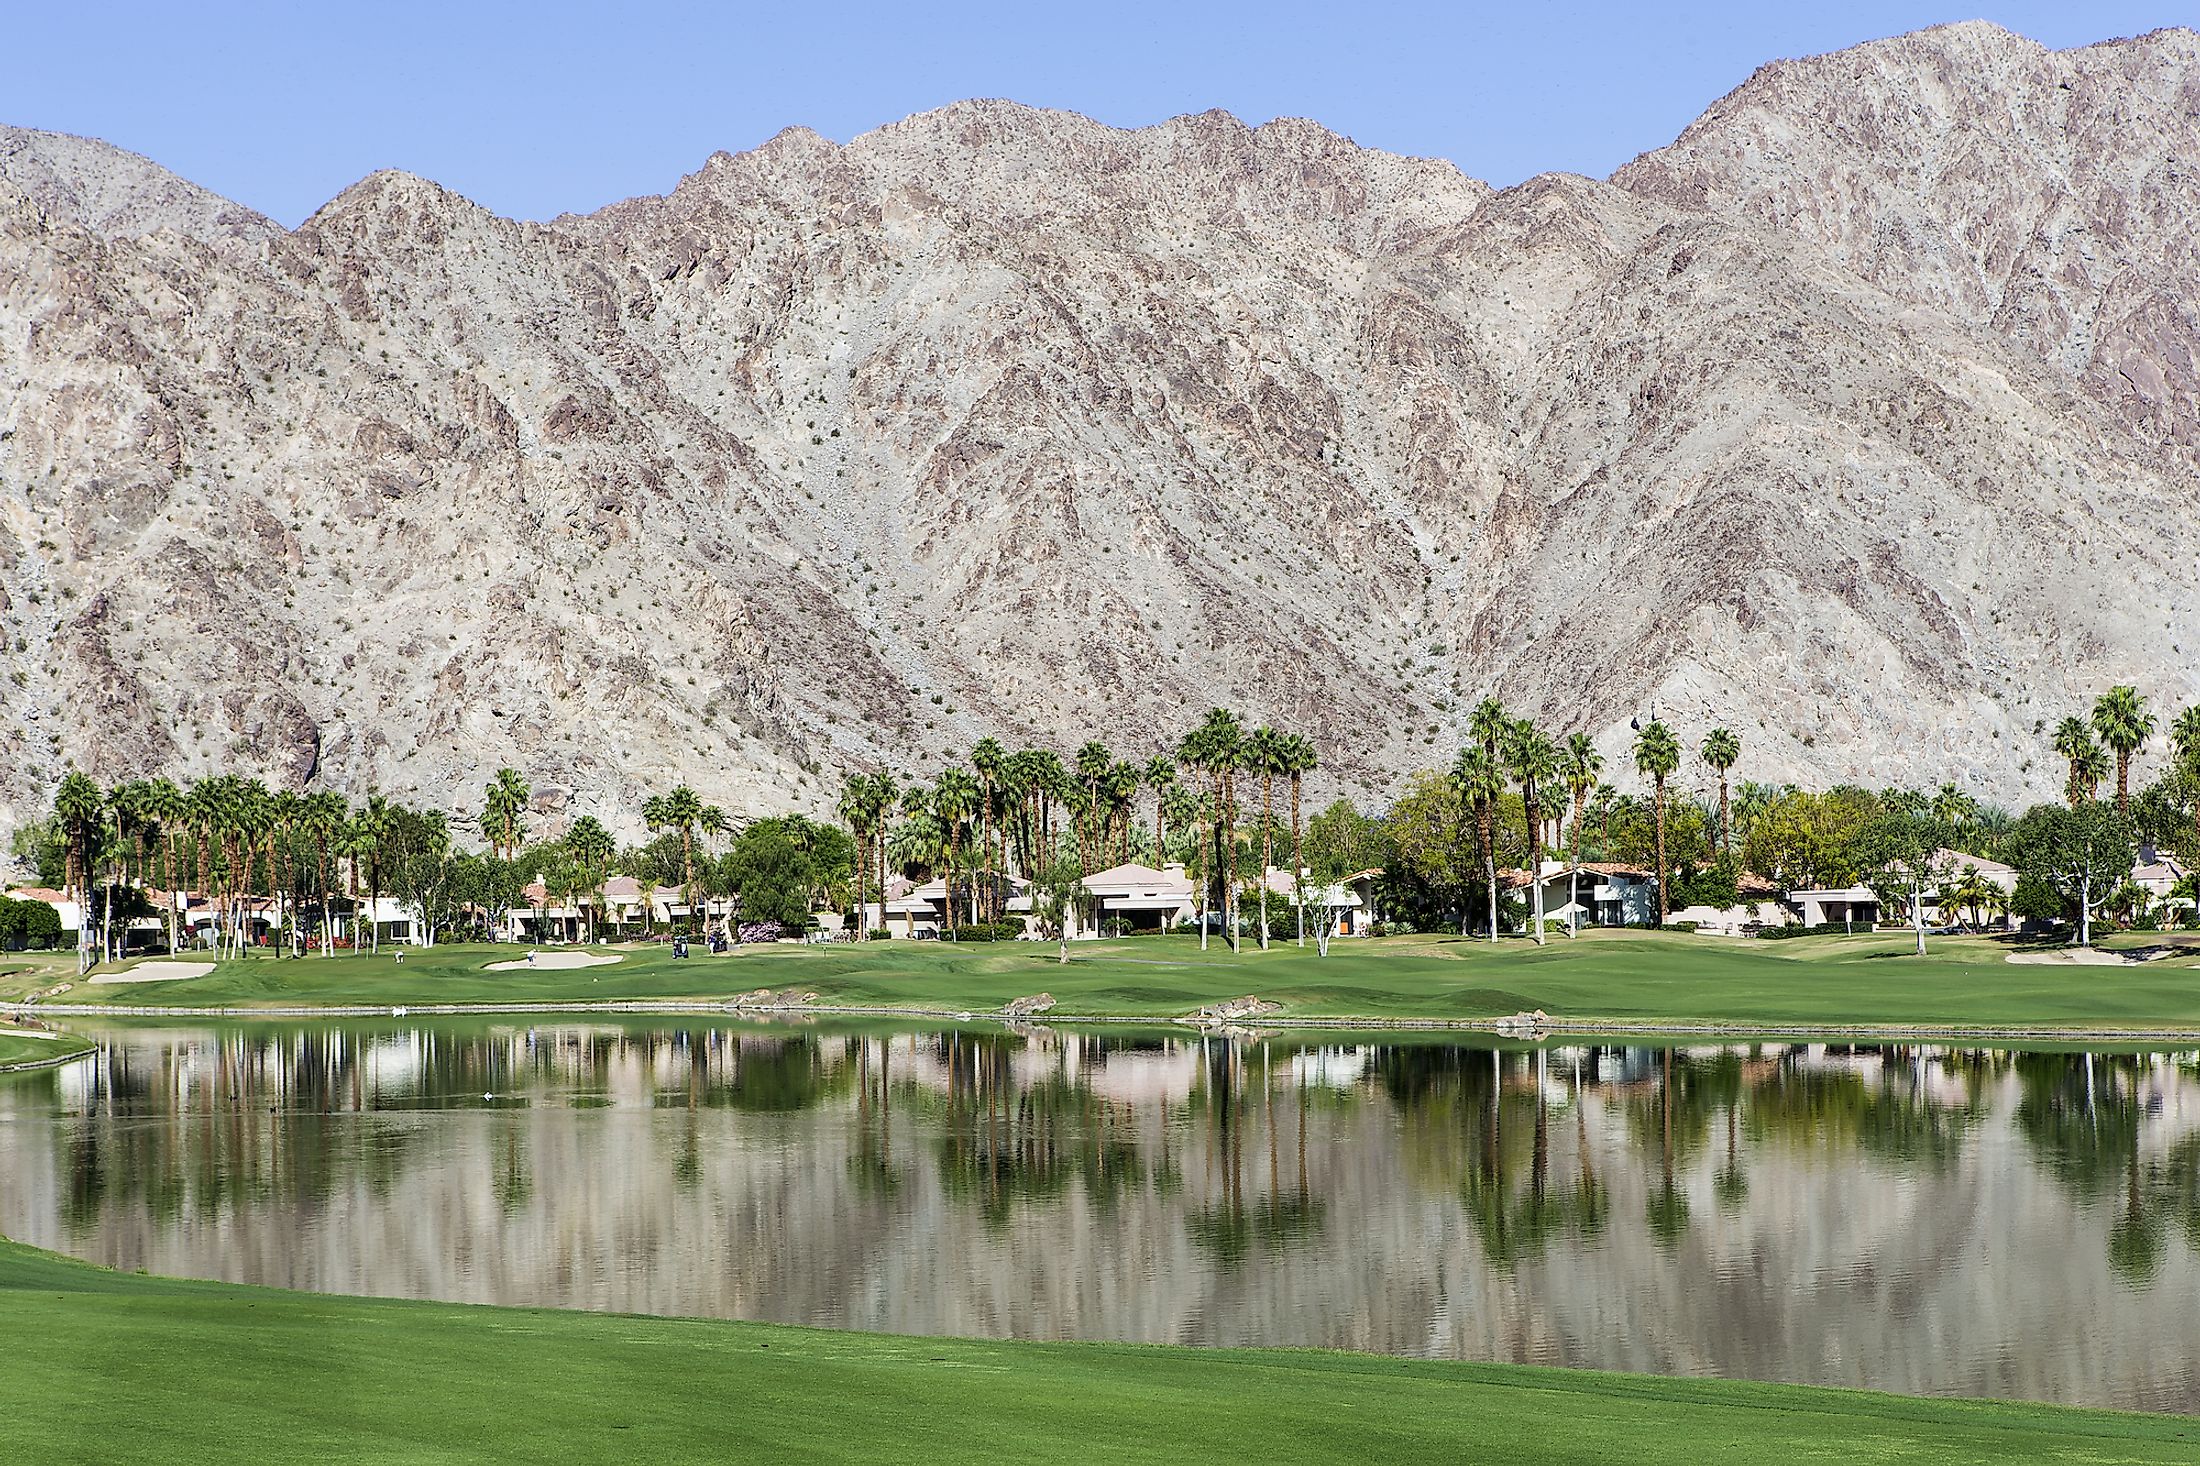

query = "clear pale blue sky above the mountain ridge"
[0,0,2200,225]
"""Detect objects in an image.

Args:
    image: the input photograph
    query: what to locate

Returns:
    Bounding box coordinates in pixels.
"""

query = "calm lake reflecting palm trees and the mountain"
[0,1024,2200,1411]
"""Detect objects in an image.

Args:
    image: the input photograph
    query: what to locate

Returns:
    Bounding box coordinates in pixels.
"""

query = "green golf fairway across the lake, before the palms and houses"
[0,931,2200,1030]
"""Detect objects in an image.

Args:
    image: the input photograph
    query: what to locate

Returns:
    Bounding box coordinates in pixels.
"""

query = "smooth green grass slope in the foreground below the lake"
[0,1244,2200,1466]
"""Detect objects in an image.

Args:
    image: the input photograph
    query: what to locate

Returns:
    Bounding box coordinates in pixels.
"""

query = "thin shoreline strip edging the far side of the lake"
[0,997,2200,1038]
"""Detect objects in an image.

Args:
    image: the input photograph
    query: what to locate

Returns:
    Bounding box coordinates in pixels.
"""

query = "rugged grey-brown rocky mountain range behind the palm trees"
[0,26,2200,830]
